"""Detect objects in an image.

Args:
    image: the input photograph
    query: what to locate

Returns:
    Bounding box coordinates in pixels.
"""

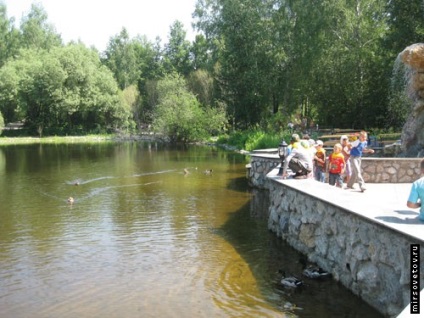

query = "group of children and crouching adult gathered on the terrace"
[282,131,374,192]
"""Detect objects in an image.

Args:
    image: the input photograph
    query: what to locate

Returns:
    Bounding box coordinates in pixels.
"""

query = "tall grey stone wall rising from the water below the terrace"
[268,180,424,317]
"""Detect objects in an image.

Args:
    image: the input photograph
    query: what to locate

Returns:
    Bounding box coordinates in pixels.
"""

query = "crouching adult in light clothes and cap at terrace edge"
[283,134,312,179]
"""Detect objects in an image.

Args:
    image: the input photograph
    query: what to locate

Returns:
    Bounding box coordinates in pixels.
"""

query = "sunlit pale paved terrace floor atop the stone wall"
[267,169,424,318]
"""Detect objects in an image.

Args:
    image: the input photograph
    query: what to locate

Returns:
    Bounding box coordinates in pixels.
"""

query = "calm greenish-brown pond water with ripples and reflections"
[0,142,380,318]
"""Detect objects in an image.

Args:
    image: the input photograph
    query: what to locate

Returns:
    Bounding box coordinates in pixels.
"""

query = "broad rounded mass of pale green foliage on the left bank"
[0,44,131,134]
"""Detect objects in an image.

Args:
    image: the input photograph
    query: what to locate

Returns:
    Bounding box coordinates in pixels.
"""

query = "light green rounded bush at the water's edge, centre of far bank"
[153,74,225,142]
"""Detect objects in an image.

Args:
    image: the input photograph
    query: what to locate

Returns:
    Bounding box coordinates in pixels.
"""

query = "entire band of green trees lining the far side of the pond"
[0,0,424,141]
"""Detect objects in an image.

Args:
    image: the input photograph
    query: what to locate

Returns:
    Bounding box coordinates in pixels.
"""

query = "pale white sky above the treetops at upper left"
[0,0,196,51]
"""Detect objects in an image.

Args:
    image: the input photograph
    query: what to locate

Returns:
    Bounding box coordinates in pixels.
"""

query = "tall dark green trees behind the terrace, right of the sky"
[194,0,410,128]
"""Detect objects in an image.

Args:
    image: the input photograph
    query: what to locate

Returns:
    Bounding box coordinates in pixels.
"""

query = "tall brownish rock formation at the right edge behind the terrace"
[399,43,424,157]
